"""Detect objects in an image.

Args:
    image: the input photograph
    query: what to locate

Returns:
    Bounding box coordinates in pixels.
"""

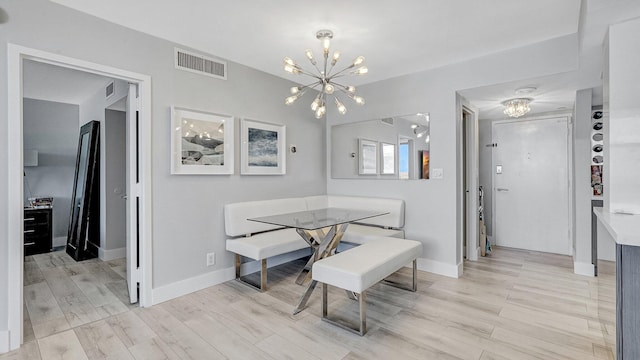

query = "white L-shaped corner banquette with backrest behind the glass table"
[224,195,404,291]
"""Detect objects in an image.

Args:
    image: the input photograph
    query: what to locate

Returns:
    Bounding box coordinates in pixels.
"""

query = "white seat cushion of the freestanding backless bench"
[312,237,422,293]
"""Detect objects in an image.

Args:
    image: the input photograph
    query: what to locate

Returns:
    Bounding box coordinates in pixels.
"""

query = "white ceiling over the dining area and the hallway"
[25,0,640,118]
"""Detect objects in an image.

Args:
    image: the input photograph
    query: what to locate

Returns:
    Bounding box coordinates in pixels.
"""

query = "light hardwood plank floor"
[0,248,615,360]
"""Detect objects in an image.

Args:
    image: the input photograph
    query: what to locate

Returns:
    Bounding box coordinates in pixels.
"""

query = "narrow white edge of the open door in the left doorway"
[126,84,140,304]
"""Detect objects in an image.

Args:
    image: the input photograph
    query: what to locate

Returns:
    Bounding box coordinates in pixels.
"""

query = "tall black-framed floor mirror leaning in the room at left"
[66,120,100,261]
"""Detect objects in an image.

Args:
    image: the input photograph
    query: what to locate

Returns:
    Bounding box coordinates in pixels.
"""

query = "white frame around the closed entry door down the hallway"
[491,112,574,256]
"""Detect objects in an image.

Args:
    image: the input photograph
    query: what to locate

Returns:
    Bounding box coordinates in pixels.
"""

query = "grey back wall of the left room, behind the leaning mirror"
[23,99,79,246]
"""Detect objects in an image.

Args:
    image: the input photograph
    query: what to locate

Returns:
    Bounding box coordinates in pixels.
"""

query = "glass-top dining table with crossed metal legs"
[247,208,388,314]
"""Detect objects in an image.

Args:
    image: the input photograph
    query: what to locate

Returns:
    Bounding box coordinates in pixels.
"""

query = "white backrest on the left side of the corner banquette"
[224,198,307,236]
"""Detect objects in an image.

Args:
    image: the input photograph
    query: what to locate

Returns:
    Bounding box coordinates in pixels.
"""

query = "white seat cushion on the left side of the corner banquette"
[227,229,309,260]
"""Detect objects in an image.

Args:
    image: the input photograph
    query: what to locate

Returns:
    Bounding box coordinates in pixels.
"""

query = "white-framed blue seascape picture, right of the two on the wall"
[240,119,287,175]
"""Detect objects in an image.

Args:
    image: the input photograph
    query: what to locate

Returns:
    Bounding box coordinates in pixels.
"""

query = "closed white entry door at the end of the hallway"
[492,117,570,255]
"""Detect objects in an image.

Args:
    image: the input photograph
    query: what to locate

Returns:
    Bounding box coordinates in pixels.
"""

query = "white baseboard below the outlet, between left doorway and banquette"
[153,267,236,305]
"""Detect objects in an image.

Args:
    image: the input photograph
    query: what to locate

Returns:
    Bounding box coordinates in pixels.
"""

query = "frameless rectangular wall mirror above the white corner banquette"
[331,112,430,180]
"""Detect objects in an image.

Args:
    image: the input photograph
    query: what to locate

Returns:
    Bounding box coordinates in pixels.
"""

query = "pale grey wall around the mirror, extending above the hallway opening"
[327,36,577,276]
